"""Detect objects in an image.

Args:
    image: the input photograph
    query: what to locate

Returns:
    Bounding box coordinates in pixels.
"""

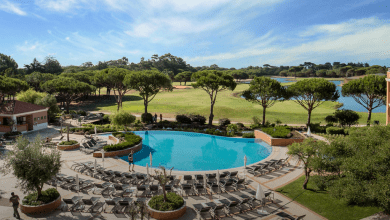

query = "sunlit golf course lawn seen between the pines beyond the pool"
[86,83,386,124]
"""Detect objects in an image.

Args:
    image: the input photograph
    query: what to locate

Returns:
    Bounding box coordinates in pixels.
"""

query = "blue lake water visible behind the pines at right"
[242,78,386,113]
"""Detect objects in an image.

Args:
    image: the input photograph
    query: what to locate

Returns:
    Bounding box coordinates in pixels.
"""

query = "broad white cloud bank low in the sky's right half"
[187,18,390,66]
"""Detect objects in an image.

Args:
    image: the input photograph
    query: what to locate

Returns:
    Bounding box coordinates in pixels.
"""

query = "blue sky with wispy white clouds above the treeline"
[0,0,390,68]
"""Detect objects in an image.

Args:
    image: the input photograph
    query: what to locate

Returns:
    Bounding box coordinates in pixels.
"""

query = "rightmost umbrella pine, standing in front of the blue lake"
[341,75,387,122]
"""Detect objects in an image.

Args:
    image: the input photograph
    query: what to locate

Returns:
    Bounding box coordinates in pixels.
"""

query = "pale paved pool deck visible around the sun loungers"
[0,128,334,220]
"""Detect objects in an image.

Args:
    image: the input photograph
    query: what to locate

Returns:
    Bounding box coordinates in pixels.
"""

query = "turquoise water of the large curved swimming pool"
[100,131,272,171]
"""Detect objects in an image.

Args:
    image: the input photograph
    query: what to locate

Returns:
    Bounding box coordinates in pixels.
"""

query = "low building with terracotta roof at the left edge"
[0,100,49,133]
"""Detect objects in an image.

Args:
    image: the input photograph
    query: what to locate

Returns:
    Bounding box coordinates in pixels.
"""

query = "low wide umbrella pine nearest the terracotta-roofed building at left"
[41,77,95,112]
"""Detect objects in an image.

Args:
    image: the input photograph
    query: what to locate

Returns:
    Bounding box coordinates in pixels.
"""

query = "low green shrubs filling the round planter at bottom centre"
[149,192,184,211]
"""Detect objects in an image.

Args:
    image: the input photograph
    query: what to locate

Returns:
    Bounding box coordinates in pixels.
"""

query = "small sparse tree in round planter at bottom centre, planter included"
[146,166,186,220]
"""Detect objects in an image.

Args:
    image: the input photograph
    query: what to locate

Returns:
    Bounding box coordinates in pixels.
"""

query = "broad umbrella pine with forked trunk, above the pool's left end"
[124,70,173,113]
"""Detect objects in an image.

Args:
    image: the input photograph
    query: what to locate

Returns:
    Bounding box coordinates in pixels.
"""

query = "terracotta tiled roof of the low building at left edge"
[0,100,47,115]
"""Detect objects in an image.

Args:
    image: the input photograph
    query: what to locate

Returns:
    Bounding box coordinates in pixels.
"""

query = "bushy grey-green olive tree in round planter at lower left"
[0,135,62,214]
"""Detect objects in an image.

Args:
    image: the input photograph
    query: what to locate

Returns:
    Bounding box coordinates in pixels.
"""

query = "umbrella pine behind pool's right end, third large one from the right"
[242,76,286,125]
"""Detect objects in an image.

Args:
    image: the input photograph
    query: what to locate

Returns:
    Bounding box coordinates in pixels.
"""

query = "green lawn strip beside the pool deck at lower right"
[276,176,383,220]
